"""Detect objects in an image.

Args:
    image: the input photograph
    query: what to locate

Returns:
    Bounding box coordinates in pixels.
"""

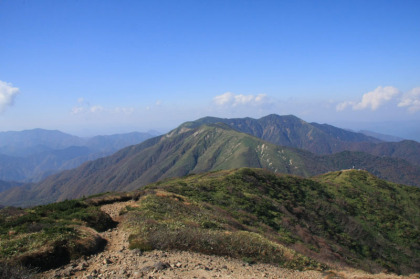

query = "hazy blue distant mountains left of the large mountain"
[0,129,156,182]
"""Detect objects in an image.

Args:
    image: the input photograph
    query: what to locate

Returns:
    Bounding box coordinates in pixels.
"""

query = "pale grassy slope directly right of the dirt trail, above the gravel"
[123,190,325,269]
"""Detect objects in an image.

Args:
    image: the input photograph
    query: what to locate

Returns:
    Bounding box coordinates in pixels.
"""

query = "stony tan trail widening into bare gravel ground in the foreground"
[39,201,420,279]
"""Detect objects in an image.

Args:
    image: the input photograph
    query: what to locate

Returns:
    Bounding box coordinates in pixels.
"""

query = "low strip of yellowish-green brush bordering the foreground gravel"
[129,226,325,269]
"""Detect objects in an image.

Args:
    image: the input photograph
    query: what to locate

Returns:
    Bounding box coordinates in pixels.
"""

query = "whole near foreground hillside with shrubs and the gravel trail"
[0,168,420,278]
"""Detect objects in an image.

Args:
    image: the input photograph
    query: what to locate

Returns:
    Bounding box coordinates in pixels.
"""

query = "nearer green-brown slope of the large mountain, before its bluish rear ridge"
[0,123,420,205]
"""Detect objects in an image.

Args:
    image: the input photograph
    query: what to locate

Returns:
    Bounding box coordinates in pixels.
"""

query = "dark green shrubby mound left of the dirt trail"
[0,200,114,269]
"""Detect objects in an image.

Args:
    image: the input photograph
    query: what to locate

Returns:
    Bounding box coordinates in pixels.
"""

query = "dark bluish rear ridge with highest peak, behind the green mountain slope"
[184,114,420,166]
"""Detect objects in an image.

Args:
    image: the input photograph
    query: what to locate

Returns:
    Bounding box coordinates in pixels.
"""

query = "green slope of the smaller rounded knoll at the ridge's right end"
[316,170,420,270]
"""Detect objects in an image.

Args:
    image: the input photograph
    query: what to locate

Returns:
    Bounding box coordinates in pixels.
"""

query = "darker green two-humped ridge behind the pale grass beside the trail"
[141,168,420,273]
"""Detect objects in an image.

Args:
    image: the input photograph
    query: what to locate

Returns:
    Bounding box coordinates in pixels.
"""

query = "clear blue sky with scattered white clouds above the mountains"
[0,0,420,141]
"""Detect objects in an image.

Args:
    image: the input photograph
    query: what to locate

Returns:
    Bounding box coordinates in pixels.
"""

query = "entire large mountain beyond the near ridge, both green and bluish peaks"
[0,115,420,208]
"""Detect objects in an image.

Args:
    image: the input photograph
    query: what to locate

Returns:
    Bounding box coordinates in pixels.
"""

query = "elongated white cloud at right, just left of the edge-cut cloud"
[336,86,401,111]
